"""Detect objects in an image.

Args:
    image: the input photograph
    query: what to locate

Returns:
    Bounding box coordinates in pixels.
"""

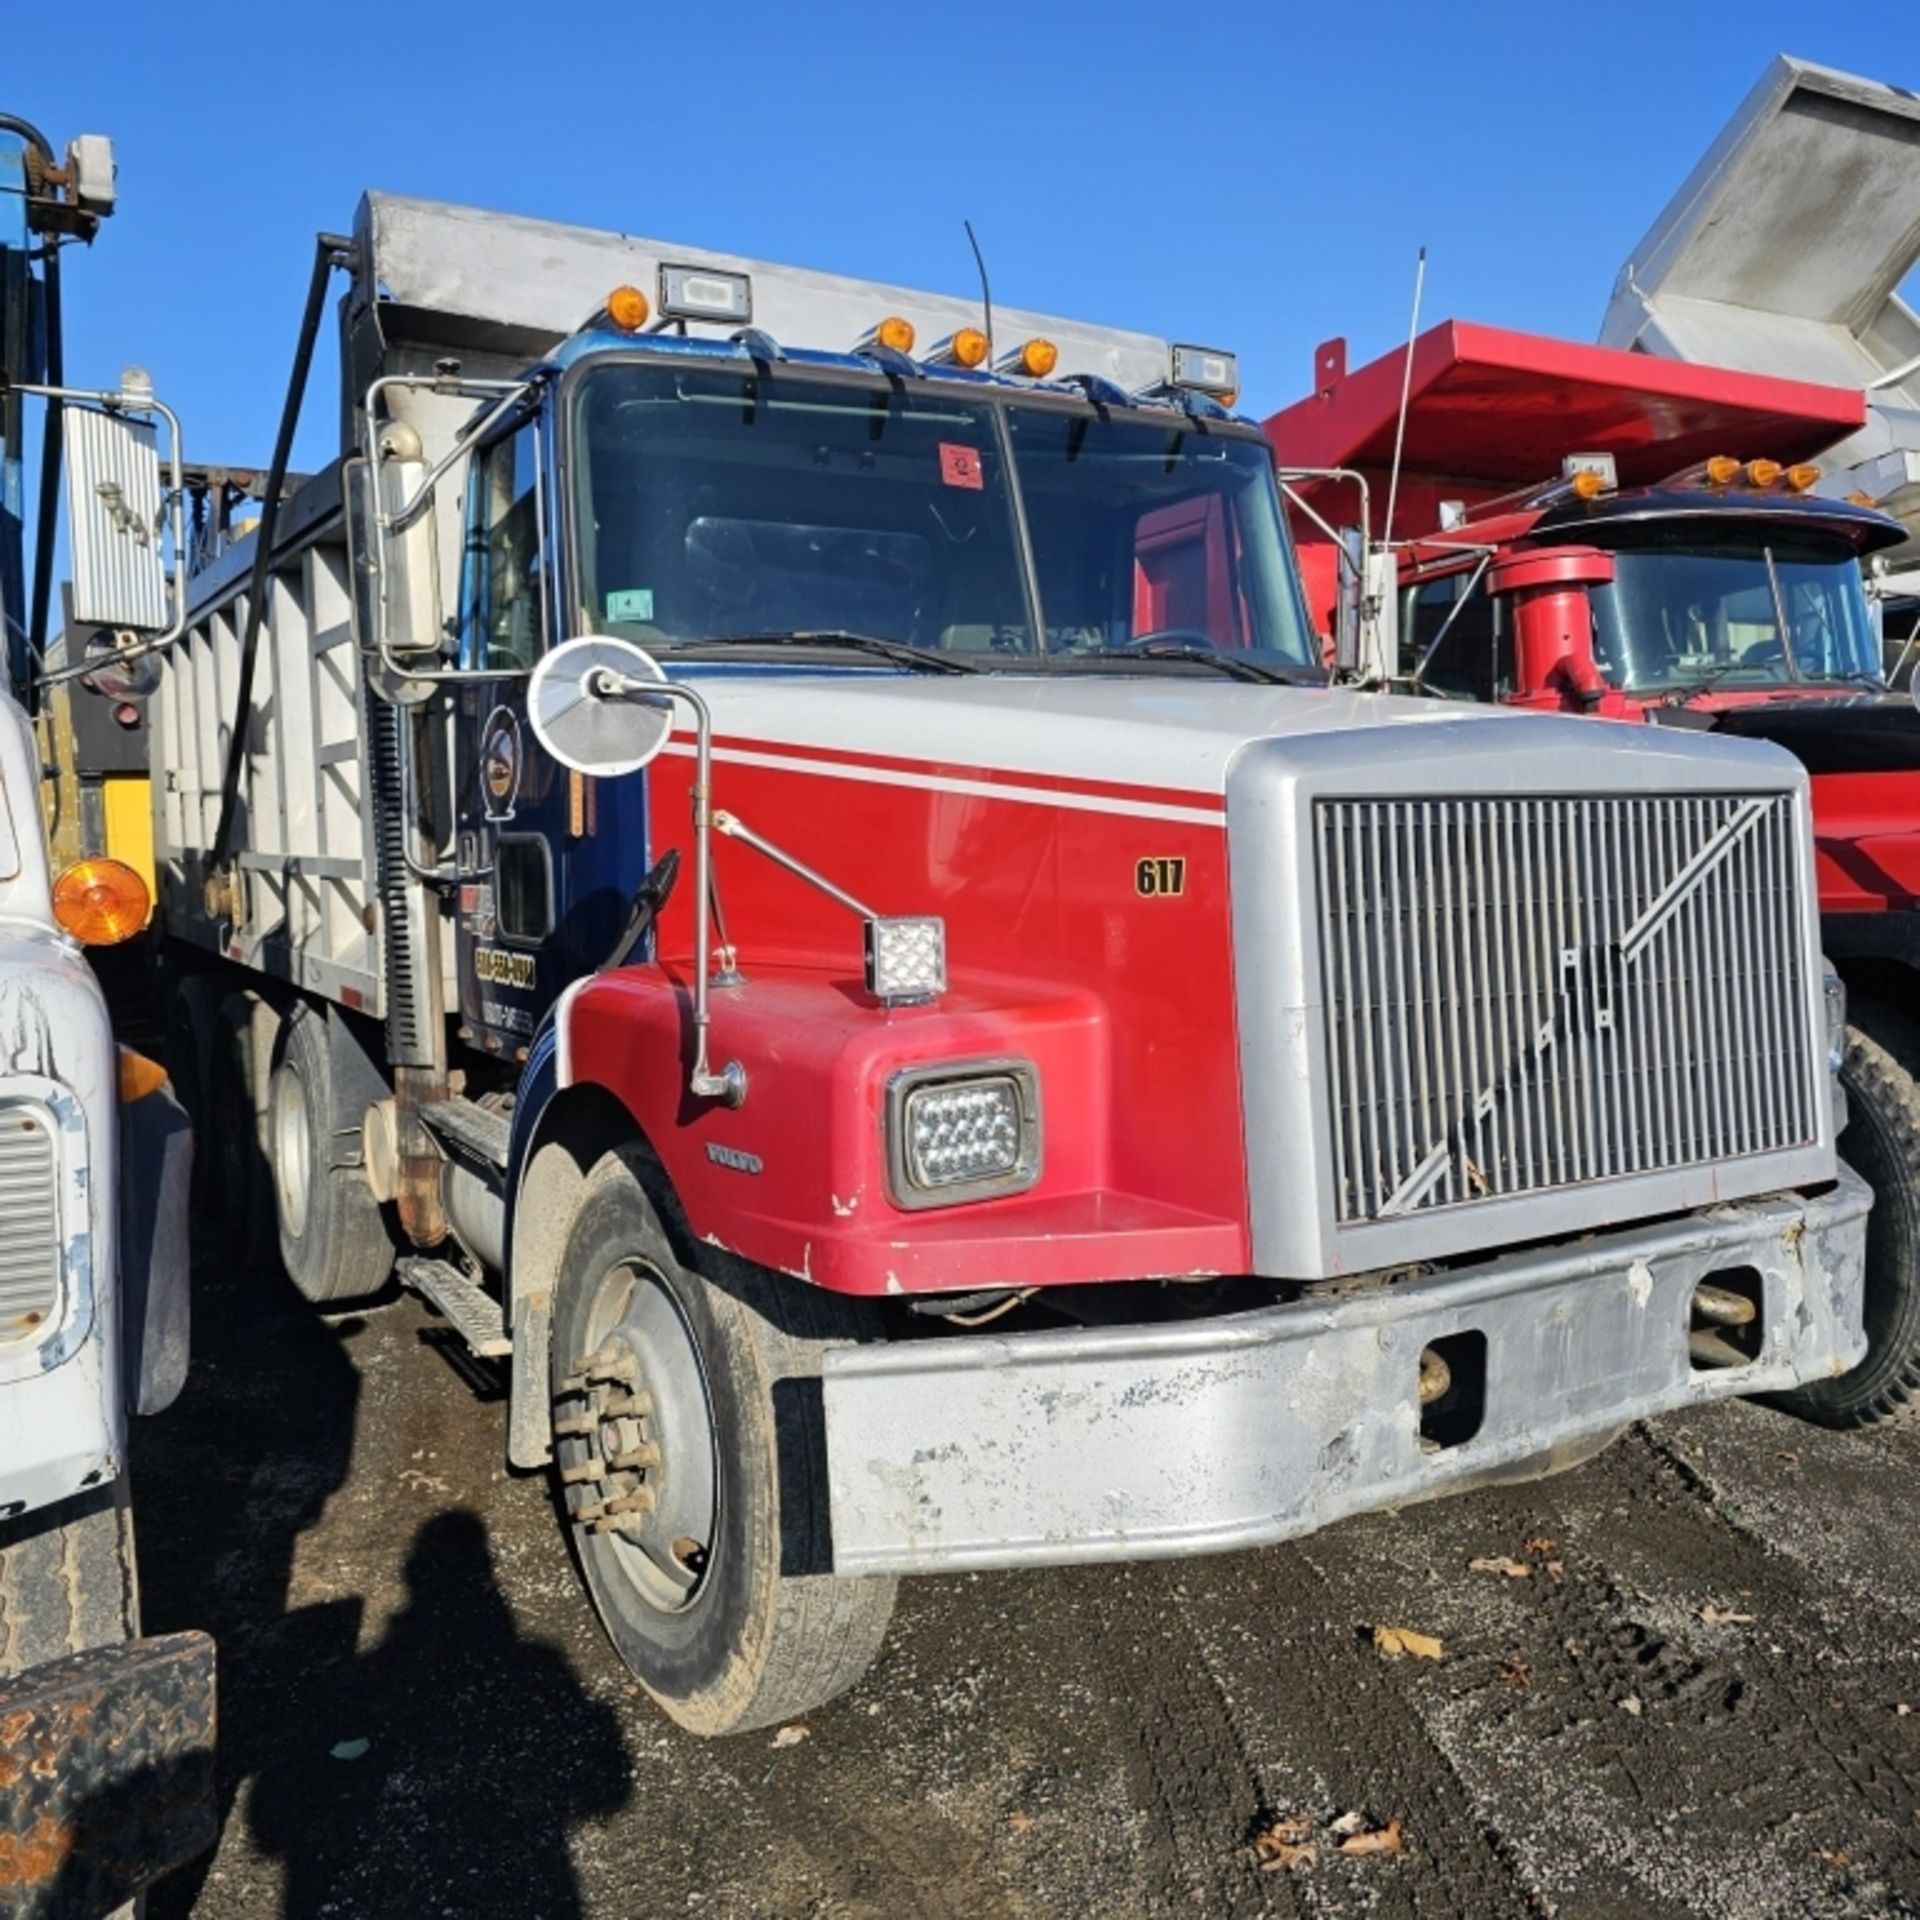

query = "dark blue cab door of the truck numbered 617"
[451,407,622,1058]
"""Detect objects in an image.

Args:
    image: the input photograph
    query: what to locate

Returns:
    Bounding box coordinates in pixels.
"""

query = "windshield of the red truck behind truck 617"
[1594,528,1880,691]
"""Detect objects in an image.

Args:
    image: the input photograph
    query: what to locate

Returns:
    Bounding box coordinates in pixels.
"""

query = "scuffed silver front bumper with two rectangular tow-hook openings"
[822,1171,1872,1572]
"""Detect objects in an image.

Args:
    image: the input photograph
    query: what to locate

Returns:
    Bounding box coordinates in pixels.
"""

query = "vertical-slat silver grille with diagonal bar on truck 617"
[1315,793,1824,1225]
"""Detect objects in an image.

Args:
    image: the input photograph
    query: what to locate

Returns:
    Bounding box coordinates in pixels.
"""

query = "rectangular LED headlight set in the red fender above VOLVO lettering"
[887,1060,1041,1208]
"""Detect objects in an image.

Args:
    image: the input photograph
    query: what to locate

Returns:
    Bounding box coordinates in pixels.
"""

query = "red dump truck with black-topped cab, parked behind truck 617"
[1265,321,1920,1427]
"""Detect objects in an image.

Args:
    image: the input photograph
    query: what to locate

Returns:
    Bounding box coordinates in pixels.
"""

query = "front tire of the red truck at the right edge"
[1774,1016,1920,1427]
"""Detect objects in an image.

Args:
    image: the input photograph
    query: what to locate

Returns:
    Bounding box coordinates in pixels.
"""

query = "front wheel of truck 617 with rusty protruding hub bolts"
[553,1152,893,1734]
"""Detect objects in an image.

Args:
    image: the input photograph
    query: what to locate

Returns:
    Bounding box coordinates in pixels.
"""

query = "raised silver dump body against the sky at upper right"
[1599,56,1920,568]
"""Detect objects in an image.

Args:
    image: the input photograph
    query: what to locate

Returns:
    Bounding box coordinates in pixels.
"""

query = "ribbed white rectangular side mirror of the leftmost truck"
[60,393,172,634]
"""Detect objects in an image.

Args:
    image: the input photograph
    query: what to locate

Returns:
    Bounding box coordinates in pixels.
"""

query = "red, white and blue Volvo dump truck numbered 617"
[139,194,1868,1734]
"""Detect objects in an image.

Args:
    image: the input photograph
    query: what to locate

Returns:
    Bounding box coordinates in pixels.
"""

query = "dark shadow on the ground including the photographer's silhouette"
[134,1258,630,1920]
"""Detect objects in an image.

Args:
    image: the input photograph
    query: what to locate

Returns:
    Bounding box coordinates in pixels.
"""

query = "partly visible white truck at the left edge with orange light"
[0,115,215,1914]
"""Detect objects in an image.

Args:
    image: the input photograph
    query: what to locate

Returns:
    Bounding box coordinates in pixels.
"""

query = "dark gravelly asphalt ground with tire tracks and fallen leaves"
[134,1260,1920,1920]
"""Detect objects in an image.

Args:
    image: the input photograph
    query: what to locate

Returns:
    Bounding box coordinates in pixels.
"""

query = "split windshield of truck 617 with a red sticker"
[574,363,1317,670]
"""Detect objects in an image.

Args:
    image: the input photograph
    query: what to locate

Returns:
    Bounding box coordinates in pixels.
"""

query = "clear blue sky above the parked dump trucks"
[15,0,1920,480]
